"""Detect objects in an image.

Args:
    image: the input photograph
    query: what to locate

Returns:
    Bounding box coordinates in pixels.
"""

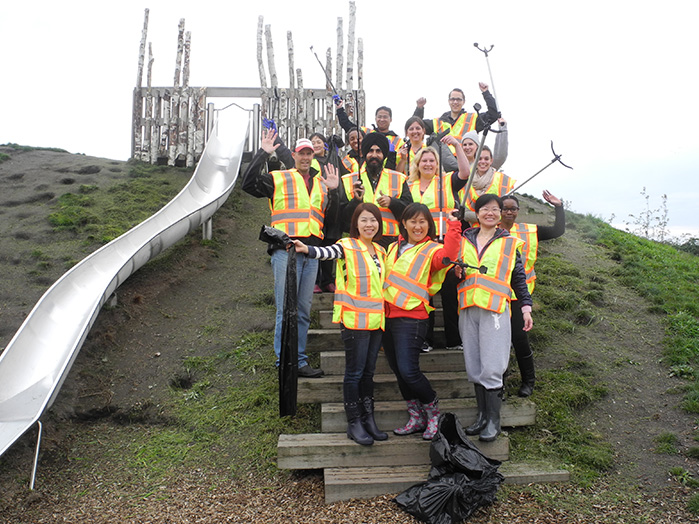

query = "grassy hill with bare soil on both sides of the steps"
[0,146,699,522]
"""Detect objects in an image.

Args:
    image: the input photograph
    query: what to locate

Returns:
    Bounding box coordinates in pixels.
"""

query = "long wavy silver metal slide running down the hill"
[0,126,246,488]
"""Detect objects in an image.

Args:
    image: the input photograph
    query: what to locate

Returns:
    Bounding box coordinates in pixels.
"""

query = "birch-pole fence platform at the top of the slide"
[131,2,365,166]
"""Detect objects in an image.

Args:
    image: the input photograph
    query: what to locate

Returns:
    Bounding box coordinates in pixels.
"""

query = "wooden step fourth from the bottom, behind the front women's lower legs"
[297,371,475,403]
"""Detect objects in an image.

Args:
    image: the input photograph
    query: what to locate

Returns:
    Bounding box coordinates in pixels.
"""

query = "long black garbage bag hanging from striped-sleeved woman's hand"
[260,226,299,417]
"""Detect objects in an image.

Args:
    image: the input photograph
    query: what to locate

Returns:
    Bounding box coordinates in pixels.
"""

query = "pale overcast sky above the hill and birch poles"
[0,0,699,236]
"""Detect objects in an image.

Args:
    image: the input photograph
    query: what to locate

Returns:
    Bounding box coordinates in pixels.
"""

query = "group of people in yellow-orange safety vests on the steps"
[243,83,565,445]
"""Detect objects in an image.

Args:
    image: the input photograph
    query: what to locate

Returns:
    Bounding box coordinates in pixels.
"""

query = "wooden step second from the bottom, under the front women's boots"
[277,433,510,469]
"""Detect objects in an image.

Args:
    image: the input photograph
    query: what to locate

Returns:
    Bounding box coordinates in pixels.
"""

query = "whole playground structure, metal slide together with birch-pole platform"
[0,2,370,489]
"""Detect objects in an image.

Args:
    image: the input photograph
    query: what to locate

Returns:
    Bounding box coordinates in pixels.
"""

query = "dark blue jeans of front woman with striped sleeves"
[340,326,383,402]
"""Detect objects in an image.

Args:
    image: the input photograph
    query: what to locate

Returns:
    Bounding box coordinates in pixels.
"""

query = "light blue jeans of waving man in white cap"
[272,249,318,368]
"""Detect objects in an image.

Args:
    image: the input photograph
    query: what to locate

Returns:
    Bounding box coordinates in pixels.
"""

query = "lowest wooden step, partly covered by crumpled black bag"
[324,462,570,504]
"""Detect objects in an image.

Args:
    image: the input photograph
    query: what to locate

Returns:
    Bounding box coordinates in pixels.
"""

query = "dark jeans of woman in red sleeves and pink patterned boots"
[383,317,437,404]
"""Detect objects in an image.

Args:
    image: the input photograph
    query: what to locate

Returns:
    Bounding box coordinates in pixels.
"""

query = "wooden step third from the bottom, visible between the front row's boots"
[320,397,536,433]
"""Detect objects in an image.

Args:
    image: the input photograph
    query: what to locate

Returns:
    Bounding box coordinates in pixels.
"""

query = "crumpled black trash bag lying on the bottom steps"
[394,413,505,524]
